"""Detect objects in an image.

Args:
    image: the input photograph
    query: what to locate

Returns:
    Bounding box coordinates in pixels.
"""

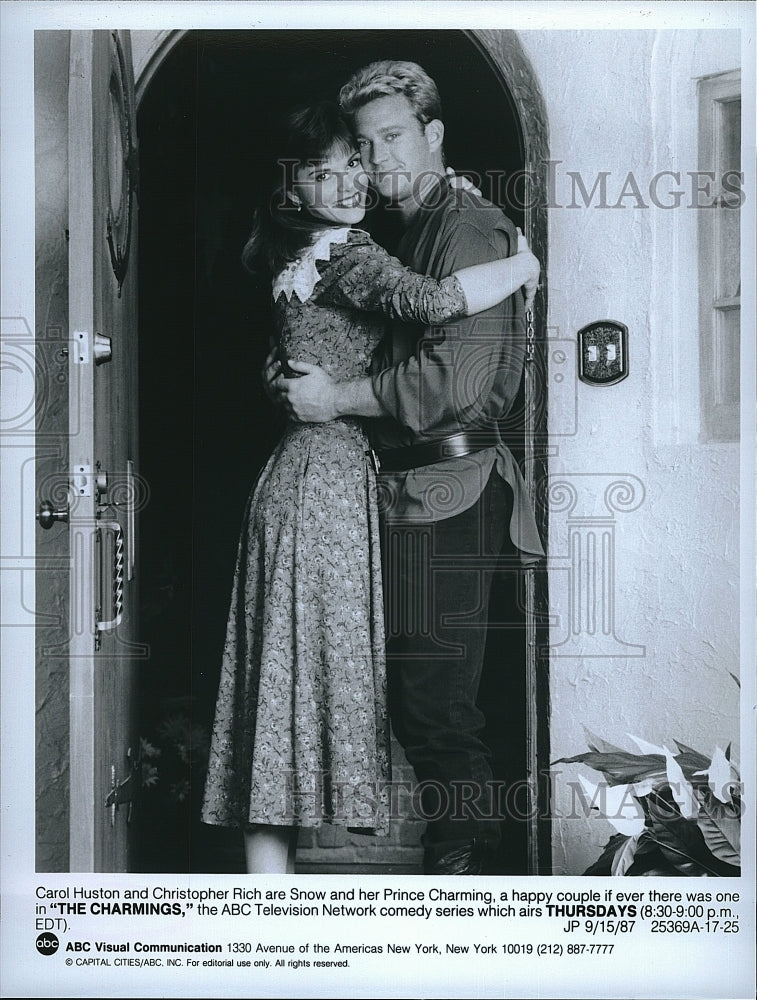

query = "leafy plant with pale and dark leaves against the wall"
[554,730,742,877]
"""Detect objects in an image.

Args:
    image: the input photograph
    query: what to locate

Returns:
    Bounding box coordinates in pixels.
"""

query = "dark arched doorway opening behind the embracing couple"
[138,31,547,874]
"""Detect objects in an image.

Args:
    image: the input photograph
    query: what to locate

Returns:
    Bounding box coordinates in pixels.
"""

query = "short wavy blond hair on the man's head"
[339,59,442,125]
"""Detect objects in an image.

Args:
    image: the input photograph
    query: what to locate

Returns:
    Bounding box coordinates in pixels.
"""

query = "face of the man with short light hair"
[354,94,435,205]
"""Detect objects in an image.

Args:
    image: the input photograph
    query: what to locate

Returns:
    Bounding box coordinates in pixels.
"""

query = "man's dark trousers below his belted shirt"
[382,471,512,861]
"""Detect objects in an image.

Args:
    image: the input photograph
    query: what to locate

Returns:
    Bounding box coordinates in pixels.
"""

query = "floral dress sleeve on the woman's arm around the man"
[313,233,468,326]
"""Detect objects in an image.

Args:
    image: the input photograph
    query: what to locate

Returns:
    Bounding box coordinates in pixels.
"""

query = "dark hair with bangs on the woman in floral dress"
[242,101,355,274]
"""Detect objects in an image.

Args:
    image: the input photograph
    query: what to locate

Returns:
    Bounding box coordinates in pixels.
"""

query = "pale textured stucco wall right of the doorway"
[520,31,740,874]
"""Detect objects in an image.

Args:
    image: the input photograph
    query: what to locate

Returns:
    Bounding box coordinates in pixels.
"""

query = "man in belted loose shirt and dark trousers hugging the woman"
[274,61,543,875]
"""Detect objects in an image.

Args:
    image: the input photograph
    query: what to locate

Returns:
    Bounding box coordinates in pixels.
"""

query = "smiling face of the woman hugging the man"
[292,145,368,226]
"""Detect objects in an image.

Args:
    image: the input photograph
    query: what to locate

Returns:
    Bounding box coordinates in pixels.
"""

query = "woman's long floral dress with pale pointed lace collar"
[202,228,466,833]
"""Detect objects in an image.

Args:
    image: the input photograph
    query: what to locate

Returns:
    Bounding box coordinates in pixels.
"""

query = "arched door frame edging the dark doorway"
[134,29,552,875]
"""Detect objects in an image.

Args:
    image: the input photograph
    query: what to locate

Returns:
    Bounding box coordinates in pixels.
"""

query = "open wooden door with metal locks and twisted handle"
[68,31,145,872]
